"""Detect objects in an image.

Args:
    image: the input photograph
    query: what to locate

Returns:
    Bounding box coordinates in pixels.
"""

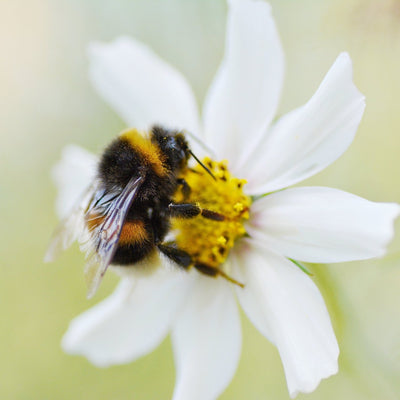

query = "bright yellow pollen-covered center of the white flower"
[172,158,251,269]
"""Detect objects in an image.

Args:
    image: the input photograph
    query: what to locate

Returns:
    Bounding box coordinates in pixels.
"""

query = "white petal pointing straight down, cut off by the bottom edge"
[172,276,241,400]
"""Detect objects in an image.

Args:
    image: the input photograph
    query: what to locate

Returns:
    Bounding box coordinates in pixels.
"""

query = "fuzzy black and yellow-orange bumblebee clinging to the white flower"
[45,126,231,297]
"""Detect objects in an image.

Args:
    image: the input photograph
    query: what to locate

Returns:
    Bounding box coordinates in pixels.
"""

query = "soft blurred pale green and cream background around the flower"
[0,0,400,400]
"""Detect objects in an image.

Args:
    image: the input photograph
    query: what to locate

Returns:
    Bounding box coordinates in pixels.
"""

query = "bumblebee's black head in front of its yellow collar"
[151,126,191,172]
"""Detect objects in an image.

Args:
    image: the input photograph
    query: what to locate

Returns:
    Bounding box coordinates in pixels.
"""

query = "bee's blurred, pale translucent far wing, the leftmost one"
[44,181,98,262]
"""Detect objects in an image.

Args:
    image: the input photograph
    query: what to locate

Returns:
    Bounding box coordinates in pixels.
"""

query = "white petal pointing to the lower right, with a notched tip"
[234,243,339,398]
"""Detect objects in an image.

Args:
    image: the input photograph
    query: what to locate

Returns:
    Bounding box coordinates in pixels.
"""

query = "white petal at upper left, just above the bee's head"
[89,37,199,134]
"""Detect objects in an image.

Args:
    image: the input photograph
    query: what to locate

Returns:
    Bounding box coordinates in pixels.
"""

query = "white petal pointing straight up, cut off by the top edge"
[204,0,284,169]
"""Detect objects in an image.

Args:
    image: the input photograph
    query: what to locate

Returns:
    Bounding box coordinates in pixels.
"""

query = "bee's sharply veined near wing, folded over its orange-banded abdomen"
[85,175,144,298]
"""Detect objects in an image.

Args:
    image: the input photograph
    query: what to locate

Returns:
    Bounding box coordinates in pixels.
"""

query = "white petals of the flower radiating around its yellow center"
[55,0,399,400]
